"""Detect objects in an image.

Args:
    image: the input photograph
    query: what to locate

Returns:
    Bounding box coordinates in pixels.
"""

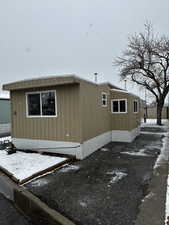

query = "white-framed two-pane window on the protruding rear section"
[111,99,127,113]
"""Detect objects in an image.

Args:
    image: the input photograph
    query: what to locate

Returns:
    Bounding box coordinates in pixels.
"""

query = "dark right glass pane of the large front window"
[41,91,56,116]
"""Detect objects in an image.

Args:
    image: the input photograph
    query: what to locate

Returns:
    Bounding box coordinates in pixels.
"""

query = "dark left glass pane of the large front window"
[27,94,40,116]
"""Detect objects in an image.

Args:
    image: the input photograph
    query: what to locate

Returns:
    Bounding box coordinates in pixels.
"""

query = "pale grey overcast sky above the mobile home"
[0,0,169,97]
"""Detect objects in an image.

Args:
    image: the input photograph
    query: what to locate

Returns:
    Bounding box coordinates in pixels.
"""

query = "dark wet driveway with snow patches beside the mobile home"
[25,128,163,225]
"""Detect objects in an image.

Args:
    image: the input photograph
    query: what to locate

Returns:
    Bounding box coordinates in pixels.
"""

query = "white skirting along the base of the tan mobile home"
[12,127,140,159]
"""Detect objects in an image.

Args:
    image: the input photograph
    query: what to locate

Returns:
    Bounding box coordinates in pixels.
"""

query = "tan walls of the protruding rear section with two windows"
[111,91,141,131]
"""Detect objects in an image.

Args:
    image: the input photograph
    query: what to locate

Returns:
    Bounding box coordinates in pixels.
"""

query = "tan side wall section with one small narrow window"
[80,81,111,142]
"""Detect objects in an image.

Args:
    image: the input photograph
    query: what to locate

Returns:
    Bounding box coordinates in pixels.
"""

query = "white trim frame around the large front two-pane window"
[25,90,58,118]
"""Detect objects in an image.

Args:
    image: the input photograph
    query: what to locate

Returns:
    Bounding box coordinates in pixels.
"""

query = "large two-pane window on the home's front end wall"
[26,91,56,117]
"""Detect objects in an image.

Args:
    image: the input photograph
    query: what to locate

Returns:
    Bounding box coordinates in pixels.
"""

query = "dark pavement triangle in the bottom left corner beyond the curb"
[0,194,33,225]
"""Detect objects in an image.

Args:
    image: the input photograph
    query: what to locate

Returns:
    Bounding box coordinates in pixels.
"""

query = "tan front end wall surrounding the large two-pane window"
[11,84,81,142]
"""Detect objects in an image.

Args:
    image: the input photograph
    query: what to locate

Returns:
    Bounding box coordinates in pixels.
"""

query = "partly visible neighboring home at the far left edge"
[0,96,11,135]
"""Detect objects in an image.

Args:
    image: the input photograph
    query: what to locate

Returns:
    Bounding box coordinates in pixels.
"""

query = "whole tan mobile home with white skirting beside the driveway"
[3,75,140,159]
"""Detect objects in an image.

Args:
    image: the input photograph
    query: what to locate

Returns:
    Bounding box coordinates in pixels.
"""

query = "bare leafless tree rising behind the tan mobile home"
[114,23,169,125]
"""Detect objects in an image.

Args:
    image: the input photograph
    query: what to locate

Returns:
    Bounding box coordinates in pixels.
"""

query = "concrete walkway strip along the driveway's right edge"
[136,120,169,225]
